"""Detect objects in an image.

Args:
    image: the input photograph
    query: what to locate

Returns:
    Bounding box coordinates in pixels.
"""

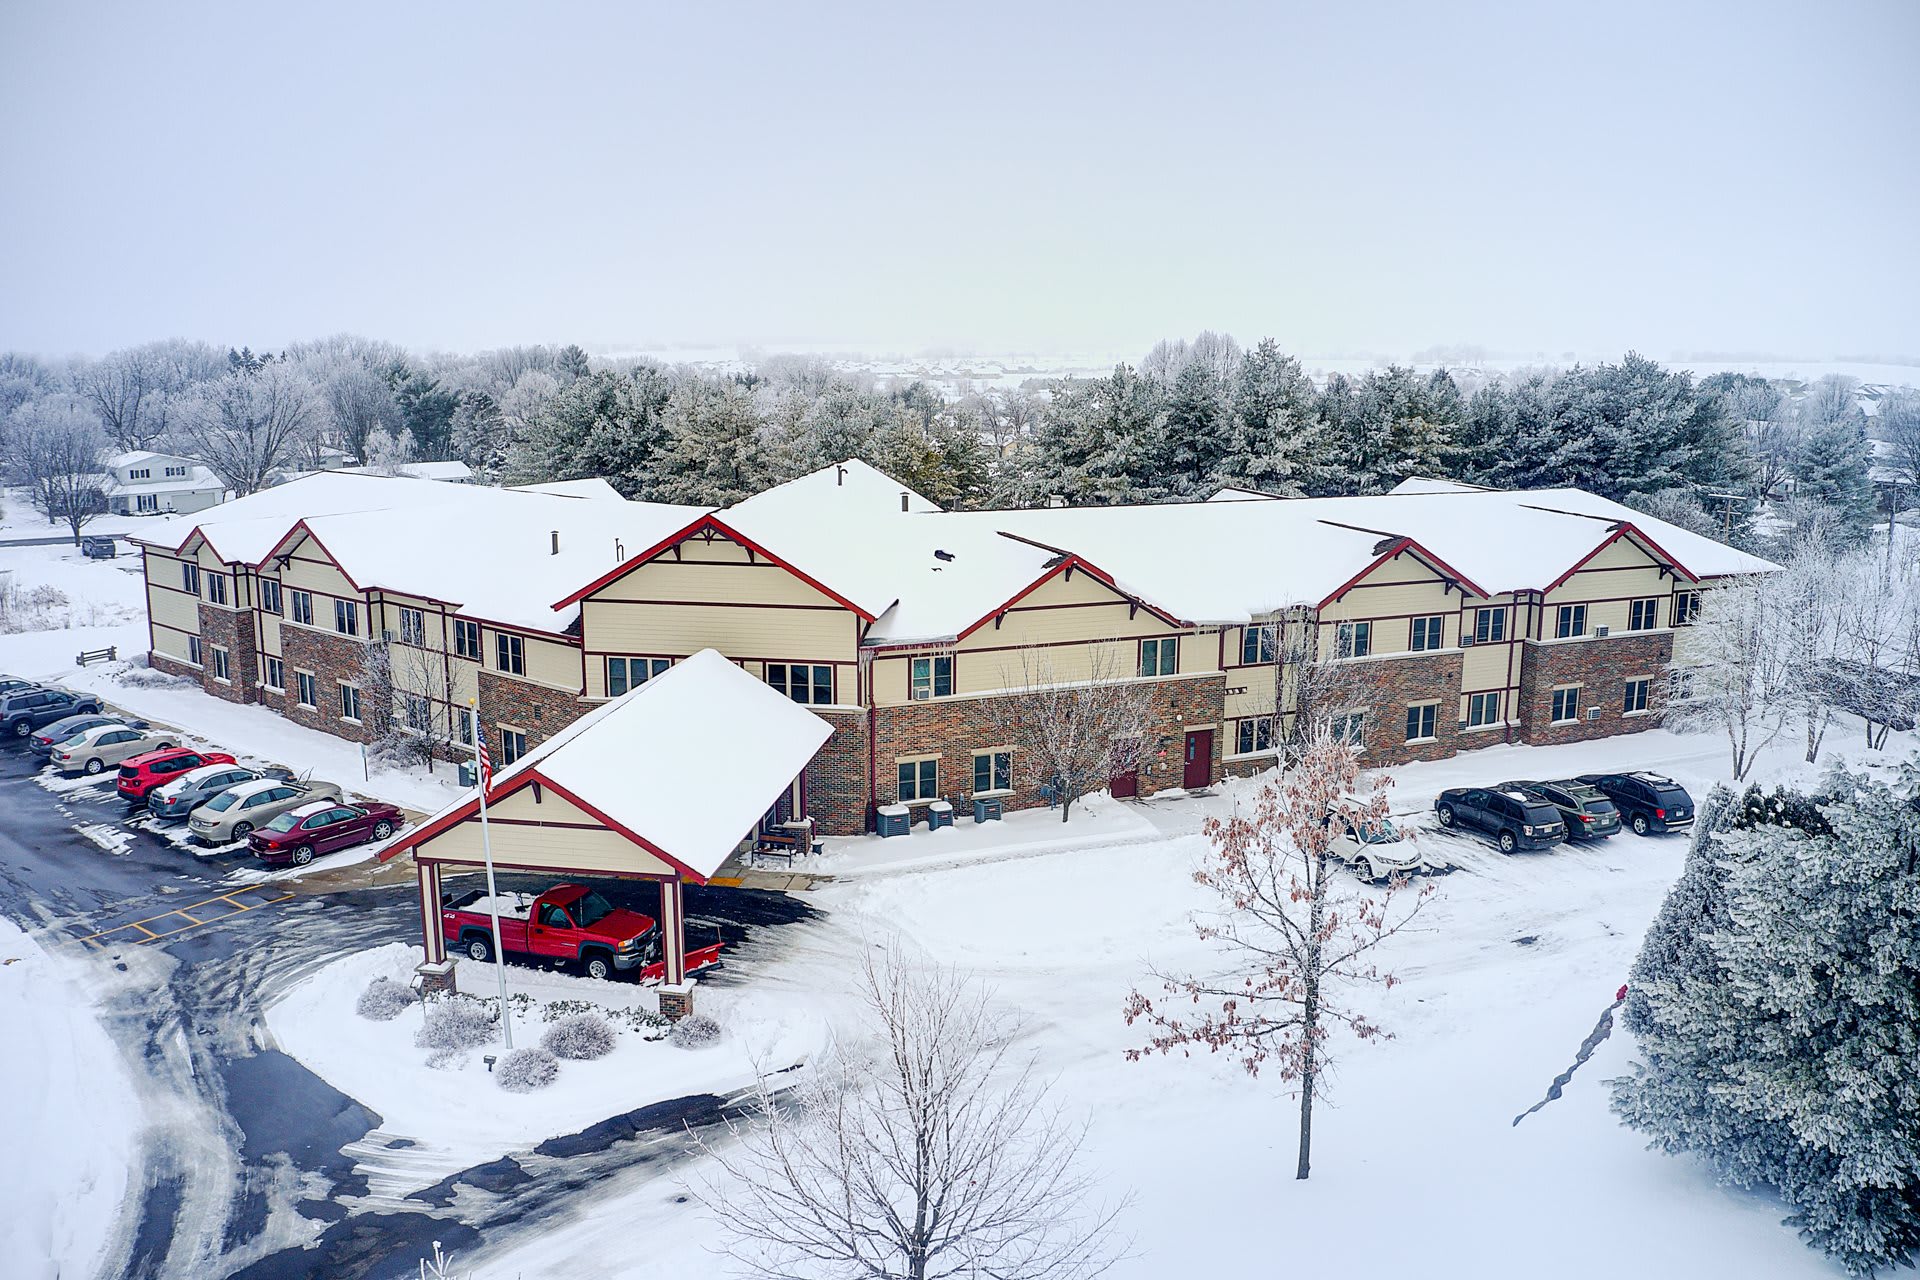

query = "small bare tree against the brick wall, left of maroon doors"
[1000,641,1150,821]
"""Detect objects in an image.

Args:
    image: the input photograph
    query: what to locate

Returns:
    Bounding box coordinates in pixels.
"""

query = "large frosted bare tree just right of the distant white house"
[177,361,321,497]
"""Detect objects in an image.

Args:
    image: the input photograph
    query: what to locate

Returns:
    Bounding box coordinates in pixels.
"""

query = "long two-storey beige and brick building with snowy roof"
[131,462,1774,833]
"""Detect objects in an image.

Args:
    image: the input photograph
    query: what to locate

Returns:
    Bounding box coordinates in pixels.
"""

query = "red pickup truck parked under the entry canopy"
[440,885,722,983]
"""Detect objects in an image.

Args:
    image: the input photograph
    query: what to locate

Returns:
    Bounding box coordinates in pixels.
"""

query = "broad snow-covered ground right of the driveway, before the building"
[459,725,1914,1280]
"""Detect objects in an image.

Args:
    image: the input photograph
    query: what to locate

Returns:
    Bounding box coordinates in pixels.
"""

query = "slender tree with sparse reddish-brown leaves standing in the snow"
[1123,733,1432,1178]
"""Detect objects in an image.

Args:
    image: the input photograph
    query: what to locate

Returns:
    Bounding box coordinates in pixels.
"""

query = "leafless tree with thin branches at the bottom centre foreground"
[697,956,1119,1280]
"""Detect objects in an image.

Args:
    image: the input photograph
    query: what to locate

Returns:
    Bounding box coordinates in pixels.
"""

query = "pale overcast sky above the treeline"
[0,0,1920,357]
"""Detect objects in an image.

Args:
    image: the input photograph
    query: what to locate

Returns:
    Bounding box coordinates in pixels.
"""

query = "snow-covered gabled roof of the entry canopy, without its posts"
[382,649,833,883]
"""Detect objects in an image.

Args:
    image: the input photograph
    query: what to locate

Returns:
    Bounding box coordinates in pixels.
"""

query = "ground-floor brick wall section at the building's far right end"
[1515,631,1674,745]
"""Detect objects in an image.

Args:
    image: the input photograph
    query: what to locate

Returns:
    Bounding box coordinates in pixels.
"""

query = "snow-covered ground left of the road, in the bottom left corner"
[0,919,140,1280]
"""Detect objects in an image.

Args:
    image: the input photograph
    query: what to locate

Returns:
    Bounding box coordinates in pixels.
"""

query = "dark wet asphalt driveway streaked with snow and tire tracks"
[0,743,810,1280]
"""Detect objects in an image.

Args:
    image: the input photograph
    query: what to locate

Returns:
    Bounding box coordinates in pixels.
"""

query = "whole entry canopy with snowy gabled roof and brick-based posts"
[380,649,833,1017]
